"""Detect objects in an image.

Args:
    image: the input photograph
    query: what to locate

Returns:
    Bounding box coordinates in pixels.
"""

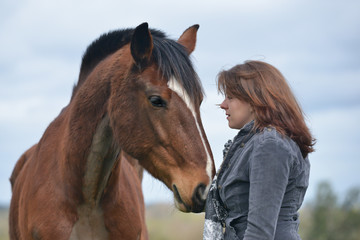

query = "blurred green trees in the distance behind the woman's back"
[300,182,360,240]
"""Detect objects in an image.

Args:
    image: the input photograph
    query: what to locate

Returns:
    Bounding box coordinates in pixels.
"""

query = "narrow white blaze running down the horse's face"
[168,78,212,199]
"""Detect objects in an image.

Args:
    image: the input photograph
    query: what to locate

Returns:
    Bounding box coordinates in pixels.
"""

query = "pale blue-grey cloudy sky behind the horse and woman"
[0,0,360,204]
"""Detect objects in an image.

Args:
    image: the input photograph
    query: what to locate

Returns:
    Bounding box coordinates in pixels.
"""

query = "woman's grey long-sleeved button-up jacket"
[204,122,310,240]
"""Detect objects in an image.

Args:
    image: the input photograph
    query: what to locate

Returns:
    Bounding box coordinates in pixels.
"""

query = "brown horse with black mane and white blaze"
[9,23,215,239]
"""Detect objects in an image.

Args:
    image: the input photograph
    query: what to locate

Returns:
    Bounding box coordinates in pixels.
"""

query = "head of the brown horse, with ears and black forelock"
[108,23,215,212]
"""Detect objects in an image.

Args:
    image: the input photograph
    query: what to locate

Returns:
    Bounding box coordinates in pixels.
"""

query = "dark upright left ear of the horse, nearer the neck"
[130,22,153,66]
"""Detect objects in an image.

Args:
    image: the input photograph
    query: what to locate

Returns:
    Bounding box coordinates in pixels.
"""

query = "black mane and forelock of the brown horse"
[72,29,203,103]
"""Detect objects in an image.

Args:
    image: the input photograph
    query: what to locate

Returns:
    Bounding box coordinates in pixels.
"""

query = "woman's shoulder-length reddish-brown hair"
[218,61,315,157]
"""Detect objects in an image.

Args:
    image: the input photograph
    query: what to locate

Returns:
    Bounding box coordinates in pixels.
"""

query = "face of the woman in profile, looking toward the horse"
[220,96,254,129]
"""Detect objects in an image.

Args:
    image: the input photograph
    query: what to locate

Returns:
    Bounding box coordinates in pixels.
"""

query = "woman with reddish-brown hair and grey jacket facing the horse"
[204,61,315,240]
